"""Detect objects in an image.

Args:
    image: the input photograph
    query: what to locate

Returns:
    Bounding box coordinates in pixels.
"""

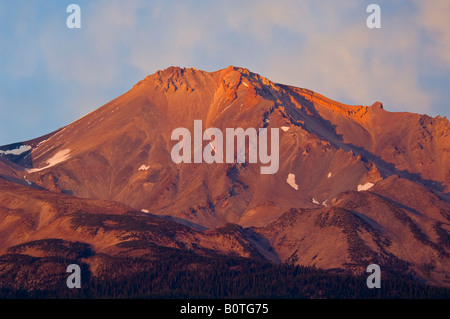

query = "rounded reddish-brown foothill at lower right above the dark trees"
[256,176,450,284]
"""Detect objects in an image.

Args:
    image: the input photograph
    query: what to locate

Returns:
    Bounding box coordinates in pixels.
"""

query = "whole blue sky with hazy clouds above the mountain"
[0,0,450,145]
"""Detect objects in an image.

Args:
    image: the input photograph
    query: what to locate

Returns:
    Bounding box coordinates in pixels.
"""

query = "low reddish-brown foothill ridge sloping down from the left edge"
[0,179,278,262]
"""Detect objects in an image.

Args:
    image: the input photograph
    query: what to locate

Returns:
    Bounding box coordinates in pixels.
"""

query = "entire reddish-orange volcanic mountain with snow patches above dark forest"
[0,66,450,292]
